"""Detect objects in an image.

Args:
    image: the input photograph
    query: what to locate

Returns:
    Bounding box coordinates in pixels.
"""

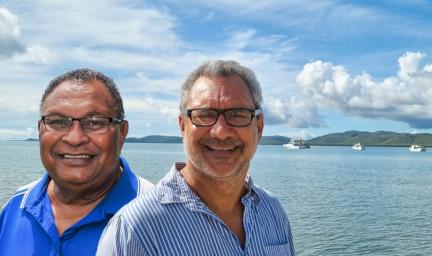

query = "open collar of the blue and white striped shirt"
[156,162,260,210]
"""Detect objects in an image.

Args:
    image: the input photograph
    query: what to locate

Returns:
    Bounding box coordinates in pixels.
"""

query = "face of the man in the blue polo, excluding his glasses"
[39,81,128,190]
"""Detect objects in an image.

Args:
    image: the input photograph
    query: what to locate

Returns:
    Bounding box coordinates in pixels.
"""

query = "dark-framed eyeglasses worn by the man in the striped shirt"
[186,109,261,127]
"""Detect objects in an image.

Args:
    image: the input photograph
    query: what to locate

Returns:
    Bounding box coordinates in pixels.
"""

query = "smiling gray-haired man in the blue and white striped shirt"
[98,60,295,255]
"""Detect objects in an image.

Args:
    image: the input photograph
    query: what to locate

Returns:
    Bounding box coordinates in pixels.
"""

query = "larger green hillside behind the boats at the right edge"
[307,131,432,147]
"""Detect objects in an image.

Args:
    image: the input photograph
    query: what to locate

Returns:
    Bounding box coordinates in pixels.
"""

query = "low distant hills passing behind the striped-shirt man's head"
[126,135,289,145]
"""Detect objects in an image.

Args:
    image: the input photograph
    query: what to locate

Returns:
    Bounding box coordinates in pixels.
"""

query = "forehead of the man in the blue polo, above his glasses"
[42,80,114,114]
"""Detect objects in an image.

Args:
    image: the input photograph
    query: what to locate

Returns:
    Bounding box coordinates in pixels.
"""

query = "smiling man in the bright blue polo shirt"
[0,69,152,256]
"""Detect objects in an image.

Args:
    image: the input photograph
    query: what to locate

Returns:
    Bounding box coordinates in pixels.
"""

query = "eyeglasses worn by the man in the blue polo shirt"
[41,115,122,133]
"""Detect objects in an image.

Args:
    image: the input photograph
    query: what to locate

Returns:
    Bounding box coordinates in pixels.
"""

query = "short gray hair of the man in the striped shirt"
[180,60,263,113]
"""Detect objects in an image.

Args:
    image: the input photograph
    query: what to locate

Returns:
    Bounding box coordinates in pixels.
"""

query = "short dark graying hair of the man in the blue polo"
[39,68,124,120]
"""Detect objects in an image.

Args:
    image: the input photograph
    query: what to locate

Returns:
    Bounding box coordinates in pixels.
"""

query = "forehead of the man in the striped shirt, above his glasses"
[187,75,254,109]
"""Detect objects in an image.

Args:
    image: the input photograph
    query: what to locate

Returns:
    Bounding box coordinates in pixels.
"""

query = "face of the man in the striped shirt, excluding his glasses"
[179,76,264,180]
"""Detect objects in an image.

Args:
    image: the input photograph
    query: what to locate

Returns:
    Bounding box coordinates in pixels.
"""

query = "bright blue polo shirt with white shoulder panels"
[0,158,153,256]
